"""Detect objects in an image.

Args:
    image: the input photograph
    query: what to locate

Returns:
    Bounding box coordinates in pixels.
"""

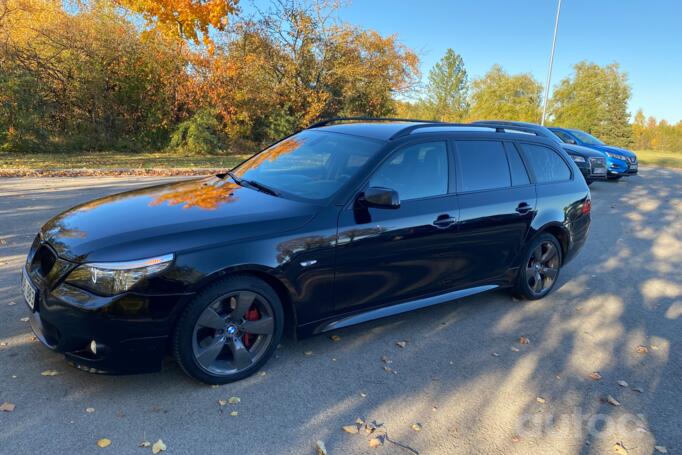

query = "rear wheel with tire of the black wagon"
[513,234,563,300]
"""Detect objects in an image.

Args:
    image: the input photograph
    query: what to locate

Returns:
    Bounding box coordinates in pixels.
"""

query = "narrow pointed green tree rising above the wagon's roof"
[425,49,469,122]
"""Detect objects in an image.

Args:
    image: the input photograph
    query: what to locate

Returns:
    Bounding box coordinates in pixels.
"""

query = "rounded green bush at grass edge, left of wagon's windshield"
[168,109,227,155]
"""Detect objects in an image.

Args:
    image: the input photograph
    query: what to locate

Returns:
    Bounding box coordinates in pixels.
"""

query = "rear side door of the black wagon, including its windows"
[453,140,537,287]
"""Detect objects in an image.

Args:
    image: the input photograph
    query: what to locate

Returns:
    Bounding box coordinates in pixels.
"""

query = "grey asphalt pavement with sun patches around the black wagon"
[0,168,682,455]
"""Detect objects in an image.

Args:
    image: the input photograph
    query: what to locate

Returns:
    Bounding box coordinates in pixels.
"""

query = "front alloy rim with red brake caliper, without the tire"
[192,291,275,376]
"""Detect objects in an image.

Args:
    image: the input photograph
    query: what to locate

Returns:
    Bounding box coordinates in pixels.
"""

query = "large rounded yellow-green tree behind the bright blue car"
[551,62,633,147]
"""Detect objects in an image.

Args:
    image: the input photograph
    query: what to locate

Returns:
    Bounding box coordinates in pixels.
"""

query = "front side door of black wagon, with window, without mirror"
[334,140,459,311]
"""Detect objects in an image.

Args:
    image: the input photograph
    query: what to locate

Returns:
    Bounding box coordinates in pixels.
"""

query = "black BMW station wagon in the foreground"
[22,119,591,383]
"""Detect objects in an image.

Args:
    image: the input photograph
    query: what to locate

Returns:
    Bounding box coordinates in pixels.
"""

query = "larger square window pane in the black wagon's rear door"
[457,141,511,191]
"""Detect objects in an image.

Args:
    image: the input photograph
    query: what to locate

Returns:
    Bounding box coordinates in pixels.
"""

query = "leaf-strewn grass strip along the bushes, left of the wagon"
[0,152,249,170]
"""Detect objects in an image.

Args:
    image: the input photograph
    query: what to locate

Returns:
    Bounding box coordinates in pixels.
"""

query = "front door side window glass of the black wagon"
[369,142,448,200]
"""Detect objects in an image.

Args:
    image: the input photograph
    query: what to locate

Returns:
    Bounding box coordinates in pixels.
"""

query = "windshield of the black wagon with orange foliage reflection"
[231,130,383,200]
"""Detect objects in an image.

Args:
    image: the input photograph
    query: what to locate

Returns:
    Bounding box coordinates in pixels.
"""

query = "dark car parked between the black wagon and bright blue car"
[473,120,607,185]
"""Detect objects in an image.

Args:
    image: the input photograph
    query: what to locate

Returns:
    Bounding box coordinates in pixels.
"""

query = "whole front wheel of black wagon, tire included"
[172,275,284,384]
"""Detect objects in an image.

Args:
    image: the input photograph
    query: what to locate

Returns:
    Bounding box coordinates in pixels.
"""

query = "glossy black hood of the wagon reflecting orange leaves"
[41,177,316,262]
